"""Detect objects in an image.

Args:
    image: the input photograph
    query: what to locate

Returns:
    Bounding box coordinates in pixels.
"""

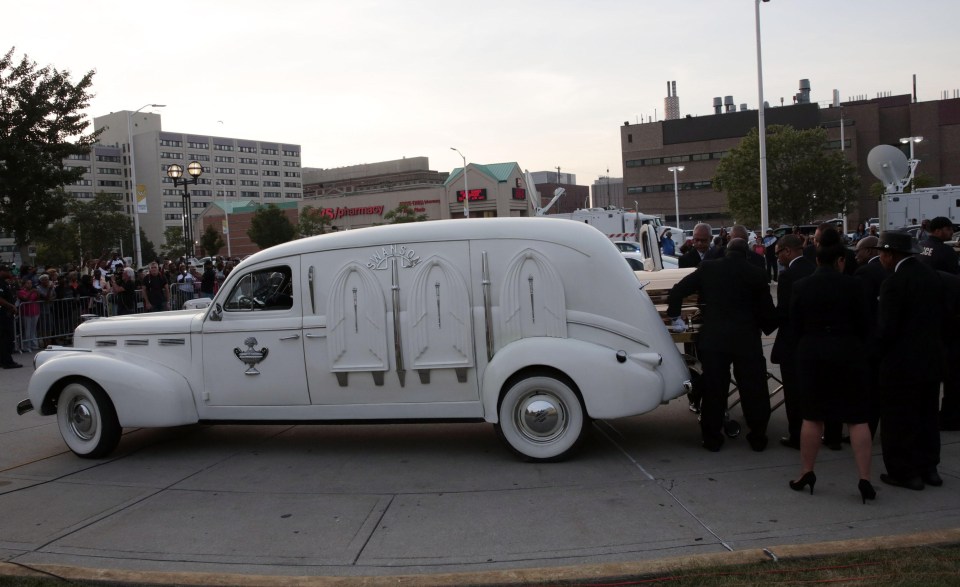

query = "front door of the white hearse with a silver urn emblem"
[201,257,309,408]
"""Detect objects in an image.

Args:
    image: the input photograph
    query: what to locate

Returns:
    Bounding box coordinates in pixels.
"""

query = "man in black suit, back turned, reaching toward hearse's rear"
[667,239,777,452]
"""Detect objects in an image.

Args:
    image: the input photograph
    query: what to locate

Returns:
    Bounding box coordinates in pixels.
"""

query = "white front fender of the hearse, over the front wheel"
[27,350,199,427]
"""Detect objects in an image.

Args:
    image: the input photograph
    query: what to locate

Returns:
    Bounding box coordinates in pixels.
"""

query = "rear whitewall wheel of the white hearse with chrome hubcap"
[495,373,585,462]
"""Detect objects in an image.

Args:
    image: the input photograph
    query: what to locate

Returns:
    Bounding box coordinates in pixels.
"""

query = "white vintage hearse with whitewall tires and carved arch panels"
[17,218,689,461]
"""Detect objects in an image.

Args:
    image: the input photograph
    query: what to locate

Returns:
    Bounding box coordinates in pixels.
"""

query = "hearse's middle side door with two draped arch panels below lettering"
[301,241,481,418]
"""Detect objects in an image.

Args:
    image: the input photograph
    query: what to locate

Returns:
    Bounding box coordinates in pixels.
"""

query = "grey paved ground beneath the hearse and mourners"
[0,340,960,585]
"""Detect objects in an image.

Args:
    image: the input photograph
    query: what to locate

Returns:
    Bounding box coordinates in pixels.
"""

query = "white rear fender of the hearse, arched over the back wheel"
[481,337,665,422]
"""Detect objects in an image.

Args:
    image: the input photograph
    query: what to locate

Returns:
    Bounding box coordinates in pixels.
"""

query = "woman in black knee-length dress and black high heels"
[790,228,876,503]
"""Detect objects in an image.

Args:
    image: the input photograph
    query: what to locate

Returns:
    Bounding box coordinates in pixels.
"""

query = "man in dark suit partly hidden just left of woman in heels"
[770,234,817,450]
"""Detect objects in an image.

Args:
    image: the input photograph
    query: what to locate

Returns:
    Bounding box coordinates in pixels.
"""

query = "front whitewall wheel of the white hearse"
[57,381,121,459]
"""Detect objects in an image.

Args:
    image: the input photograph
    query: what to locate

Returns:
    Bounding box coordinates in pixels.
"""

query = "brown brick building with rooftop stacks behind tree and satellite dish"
[620,87,960,228]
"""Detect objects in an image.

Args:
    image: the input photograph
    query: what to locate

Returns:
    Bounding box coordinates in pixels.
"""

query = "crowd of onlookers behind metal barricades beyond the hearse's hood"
[0,253,237,369]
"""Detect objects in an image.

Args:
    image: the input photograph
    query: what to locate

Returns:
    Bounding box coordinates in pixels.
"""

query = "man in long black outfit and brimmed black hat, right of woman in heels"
[877,231,945,490]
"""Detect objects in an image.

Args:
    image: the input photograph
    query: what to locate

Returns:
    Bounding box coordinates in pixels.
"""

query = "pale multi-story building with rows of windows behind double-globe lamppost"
[86,110,303,258]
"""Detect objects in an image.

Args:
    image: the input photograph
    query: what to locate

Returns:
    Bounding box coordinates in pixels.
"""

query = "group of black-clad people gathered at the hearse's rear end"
[667,217,960,503]
